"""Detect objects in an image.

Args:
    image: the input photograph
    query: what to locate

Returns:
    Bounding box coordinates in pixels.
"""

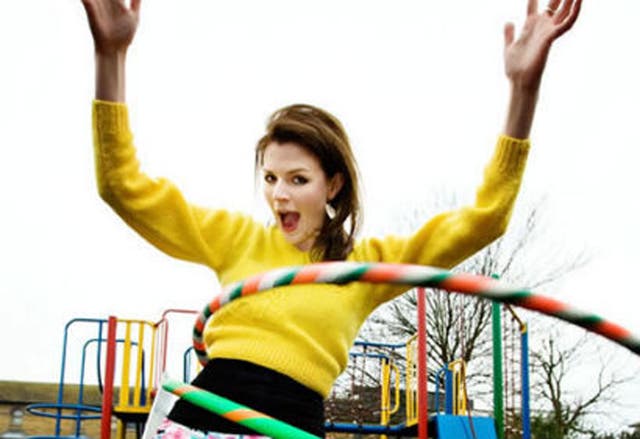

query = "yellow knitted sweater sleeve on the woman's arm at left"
[93,101,255,270]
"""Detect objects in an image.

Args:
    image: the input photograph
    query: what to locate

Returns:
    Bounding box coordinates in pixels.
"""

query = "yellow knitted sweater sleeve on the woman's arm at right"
[354,136,530,305]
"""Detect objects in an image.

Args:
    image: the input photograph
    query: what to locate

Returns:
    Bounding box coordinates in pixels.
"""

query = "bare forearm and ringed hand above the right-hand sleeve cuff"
[504,0,582,139]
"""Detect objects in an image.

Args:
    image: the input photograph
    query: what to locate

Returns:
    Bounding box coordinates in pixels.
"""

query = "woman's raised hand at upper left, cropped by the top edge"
[82,0,141,56]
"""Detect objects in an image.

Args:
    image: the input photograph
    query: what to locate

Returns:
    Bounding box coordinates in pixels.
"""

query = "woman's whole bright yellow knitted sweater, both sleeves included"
[93,101,529,397]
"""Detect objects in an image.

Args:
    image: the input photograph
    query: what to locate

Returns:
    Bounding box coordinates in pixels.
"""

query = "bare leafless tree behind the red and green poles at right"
[361,197,587,391]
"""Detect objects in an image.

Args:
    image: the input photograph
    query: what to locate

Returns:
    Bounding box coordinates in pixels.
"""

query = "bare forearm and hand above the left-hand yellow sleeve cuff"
[82,0,141,102]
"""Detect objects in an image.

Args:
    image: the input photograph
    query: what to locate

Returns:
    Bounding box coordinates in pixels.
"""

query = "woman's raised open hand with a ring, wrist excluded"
[504,0,582,92]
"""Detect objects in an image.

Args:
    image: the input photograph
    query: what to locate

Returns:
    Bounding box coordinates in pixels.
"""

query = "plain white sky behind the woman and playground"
[0,0,640,434]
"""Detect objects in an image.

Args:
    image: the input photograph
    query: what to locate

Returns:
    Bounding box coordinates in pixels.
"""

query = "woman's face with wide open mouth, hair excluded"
[262,142,342,251]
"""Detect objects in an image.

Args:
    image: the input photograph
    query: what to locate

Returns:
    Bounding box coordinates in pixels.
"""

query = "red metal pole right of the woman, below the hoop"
[417,288,429,439]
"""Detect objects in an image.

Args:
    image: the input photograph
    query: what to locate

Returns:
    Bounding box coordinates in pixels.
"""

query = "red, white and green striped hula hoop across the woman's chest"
[193,262,640,365]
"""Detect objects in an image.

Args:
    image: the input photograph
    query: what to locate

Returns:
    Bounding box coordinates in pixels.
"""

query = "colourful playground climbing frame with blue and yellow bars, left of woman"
[27,309,196,439]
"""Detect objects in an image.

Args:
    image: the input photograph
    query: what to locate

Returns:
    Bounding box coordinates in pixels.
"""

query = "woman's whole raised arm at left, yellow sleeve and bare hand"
[77,0,253,270]
